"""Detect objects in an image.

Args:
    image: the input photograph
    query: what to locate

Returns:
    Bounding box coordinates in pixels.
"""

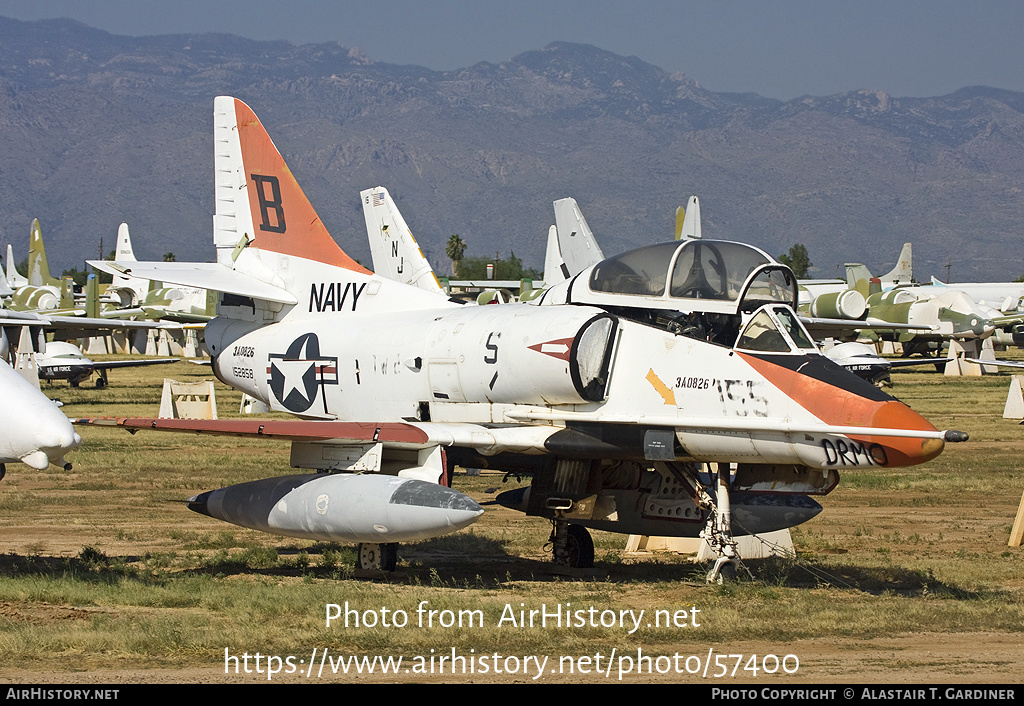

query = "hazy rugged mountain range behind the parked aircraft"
[0,17,1024,281]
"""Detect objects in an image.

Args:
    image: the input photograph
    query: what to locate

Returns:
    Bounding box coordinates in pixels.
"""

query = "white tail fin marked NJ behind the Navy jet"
[359,186,444,294]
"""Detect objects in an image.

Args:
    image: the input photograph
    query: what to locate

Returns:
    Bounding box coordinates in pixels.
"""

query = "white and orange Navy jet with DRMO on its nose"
[82,97,966,574]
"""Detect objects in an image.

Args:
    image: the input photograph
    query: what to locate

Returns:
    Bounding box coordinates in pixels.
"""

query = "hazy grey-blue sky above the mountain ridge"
[0,0,1024,98]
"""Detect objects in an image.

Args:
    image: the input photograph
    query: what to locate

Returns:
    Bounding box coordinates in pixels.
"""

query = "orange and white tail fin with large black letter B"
[213,96,370,274]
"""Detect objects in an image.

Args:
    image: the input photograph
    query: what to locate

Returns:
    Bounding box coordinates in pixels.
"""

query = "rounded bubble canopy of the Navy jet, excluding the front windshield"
[573,239,797,314]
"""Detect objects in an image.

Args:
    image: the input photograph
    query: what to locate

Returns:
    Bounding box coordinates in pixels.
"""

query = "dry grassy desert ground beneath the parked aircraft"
[0,362,1024,686]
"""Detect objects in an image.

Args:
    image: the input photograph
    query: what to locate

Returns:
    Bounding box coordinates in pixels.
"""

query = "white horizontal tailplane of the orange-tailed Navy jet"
[89,260,298,304]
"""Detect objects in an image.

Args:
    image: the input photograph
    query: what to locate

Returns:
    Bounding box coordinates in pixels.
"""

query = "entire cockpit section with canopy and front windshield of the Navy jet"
[541,239,816,354]
